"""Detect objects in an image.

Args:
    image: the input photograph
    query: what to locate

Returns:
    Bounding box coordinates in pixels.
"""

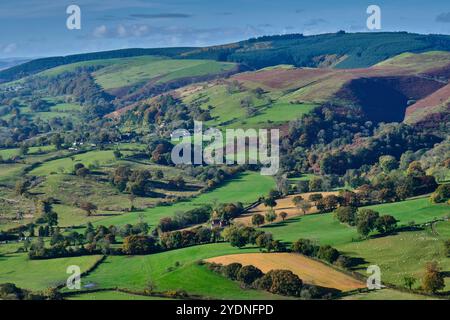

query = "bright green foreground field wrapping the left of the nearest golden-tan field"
[77,243,278,299]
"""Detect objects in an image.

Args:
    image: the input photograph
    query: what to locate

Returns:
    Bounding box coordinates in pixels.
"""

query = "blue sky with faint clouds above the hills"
[0,0,450,58]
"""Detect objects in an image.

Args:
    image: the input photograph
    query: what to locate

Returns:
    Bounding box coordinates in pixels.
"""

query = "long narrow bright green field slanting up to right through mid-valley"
[97,172,274,226]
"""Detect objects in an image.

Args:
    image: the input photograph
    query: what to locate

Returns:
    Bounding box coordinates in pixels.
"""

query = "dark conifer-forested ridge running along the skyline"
[0,32,450,82]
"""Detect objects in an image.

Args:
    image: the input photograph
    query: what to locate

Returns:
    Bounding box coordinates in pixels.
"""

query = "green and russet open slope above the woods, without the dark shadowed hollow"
[178,52,450,128]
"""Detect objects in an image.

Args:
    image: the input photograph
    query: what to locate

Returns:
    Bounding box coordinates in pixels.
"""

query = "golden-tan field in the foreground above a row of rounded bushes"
[206,253,366,291]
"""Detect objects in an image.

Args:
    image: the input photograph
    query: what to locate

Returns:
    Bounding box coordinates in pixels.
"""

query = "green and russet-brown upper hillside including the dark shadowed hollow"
[114,51,450,127]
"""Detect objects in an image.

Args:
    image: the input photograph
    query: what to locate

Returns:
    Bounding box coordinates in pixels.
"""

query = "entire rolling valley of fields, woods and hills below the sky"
[0,28,450,304]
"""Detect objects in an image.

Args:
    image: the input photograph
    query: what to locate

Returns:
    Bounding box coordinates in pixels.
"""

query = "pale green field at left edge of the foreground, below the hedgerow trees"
[0,253,100,290]
